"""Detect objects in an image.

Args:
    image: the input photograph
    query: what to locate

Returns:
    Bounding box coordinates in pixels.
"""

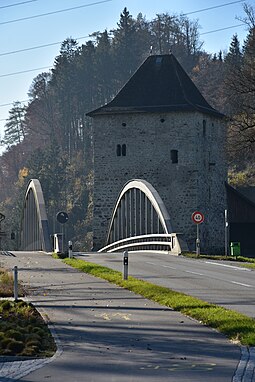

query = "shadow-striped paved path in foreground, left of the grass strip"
[0,252,245,382]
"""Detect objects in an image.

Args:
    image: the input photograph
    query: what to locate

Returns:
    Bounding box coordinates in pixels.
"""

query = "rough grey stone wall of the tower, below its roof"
[93,112,227,252]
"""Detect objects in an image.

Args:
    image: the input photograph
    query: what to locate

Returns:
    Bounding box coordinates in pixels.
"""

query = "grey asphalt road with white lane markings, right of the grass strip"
[78,253,255,318]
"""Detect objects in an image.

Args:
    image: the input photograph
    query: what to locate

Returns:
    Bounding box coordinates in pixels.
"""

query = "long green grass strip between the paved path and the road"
[63,259,255,346]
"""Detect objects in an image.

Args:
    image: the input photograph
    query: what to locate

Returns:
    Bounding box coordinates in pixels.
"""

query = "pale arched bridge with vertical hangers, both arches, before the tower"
[18,179,187,255]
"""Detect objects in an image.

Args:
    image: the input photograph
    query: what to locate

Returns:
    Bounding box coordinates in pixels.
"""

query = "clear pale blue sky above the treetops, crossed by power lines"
[0,0,250,152]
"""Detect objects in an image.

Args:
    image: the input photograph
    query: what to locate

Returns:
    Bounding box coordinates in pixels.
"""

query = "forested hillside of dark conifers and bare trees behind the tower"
[0,5,255,249]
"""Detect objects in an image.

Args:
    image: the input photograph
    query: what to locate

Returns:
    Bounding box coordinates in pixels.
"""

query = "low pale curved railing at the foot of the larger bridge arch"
[98,233,181,255]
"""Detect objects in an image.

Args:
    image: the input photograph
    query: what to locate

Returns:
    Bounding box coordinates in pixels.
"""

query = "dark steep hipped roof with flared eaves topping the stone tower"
[87,54,224,118]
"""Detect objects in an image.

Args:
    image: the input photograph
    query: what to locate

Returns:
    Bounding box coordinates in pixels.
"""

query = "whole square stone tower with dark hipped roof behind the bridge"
[88,54,227,253]
